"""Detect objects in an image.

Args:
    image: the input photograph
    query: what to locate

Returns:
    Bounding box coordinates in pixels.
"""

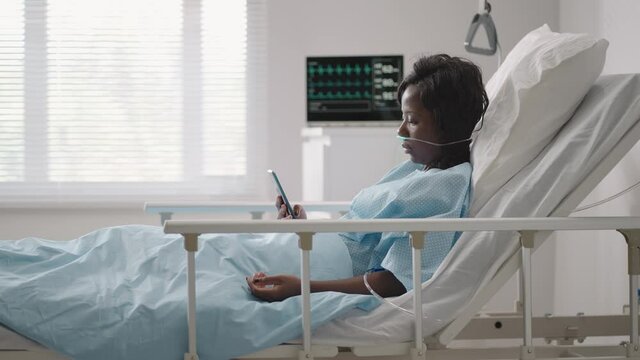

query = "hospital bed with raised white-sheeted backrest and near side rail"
[0,71,640,359]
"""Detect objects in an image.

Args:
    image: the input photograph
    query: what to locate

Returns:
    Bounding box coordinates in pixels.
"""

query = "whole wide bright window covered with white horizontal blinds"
[0,0,265,200]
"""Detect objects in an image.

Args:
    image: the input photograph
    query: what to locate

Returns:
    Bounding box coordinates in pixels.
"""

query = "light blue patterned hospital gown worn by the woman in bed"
[341,161,471,290]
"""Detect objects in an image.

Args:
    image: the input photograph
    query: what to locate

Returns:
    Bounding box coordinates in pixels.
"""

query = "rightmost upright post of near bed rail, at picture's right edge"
[618,229,640,358]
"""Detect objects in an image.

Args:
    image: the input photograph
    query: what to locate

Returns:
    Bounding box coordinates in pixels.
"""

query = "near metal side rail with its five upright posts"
[164,217,640,360]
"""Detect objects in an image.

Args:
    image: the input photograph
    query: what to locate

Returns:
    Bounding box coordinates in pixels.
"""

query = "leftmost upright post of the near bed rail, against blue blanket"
[182,234,199,360]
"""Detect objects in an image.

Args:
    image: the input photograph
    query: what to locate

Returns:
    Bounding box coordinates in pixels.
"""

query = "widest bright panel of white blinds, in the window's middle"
[42,0,182,182]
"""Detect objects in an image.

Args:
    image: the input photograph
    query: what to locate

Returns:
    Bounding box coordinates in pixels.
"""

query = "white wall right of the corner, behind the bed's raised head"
[554,0,640,314]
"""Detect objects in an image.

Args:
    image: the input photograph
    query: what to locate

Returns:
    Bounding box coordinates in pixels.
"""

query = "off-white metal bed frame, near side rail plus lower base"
[164,217,640,360]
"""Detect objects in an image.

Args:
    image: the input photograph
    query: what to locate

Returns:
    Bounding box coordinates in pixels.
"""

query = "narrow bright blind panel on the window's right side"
[202,1,247,175]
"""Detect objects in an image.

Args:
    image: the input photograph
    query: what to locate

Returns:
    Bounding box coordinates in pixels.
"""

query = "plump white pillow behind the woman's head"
[471,24,609,211]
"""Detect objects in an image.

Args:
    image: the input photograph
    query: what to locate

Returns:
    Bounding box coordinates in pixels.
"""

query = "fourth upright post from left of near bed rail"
[520,231,536,360]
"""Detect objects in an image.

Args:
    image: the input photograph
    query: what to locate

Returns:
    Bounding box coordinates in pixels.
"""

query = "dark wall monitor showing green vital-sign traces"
[307,55,403,125]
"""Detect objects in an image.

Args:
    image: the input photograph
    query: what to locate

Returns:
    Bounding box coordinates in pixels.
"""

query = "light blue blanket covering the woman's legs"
[0,225,378,360]
